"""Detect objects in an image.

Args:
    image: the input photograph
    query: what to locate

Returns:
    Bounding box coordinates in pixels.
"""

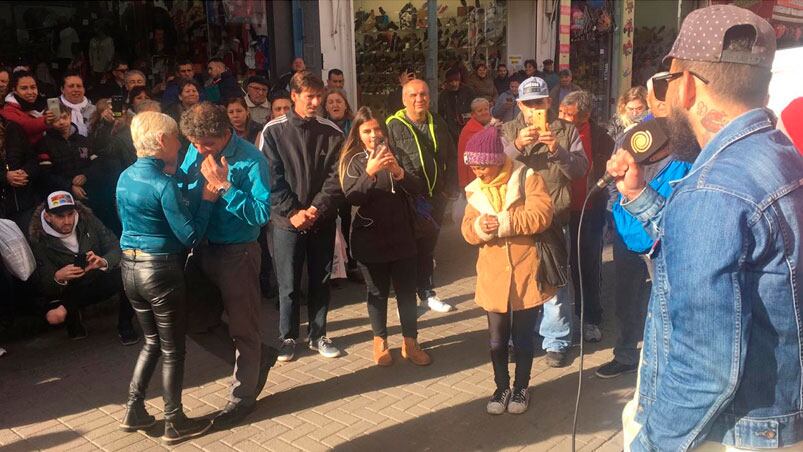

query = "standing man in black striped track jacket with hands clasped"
[259,71,345,361]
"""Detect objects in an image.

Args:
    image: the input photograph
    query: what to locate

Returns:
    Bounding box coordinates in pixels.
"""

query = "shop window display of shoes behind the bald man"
[354,0,507,118]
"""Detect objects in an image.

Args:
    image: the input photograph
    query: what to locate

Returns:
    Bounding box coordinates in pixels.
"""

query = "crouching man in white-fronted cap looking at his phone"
[28,191,139,345]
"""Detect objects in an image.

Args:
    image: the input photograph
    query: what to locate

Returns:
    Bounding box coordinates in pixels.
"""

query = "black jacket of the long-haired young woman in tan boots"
[341,151,424,263]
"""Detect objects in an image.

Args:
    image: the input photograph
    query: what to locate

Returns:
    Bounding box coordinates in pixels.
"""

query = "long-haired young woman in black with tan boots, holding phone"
[339,107,432,366]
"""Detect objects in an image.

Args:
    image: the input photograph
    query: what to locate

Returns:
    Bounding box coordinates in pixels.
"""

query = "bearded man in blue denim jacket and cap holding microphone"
[607,5,803,451]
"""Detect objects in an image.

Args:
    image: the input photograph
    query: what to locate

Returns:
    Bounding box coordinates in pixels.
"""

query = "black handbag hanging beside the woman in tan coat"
[519,168,569,289]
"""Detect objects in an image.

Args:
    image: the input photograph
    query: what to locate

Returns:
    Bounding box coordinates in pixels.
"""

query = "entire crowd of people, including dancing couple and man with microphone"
[0,6,803,450]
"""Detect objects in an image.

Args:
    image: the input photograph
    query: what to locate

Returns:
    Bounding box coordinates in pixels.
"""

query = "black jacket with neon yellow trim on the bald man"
[385,110,457,198]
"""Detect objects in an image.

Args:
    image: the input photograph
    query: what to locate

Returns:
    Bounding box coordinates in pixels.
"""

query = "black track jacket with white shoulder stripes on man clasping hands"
[262,109,343,230]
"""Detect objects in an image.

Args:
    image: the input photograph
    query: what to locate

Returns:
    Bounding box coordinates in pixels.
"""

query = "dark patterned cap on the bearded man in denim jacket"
[664,5,775,68]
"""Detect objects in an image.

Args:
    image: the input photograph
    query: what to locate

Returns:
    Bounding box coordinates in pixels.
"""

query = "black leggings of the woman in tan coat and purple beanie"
[486,308,539,389]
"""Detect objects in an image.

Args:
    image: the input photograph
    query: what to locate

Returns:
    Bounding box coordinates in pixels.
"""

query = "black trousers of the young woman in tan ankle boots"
[359,257,418,339]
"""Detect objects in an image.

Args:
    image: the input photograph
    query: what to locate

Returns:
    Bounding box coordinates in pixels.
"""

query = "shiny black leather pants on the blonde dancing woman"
[121,254,187,420]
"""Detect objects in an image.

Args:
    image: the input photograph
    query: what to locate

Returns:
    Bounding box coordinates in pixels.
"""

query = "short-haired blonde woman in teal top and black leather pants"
[117,112,218,444]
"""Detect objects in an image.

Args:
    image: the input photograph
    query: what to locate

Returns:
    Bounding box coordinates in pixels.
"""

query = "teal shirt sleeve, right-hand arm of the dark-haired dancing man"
[221,155,270,226]
